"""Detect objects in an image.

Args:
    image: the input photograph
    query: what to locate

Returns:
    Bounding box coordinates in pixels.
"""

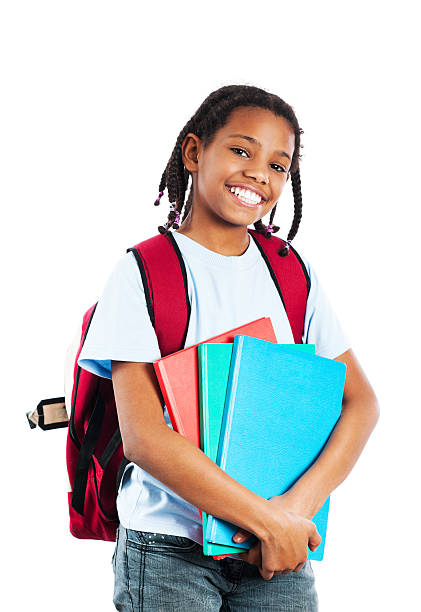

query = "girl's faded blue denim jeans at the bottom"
[112,524,318,612]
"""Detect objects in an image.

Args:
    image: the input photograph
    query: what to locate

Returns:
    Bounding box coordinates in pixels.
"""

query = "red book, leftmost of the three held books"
[153,317,277,559]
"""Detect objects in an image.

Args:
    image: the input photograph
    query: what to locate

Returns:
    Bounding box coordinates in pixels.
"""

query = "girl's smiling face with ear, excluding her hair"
[182,106,295,227]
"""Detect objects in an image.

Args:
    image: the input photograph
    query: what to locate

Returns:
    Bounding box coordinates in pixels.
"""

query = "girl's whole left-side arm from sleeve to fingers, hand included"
[111,361,321,580]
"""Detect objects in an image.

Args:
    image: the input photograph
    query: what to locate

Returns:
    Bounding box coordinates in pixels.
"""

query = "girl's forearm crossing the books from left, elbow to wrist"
[128,425,273,539]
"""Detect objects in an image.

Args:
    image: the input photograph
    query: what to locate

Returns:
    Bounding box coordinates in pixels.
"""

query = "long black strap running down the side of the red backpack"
[72,391,105,516]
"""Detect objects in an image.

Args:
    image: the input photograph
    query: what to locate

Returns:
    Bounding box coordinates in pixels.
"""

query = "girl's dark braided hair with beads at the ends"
[154,85,303,257]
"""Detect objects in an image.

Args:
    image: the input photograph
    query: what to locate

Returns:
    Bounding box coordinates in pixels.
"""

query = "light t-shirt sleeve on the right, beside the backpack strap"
[301,257,351,359]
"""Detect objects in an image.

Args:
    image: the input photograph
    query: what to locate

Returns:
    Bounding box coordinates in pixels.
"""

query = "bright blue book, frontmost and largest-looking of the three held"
[206,335,346,561]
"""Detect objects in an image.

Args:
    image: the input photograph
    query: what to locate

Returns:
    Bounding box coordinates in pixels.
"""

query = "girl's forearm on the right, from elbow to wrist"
[290,395,379,519]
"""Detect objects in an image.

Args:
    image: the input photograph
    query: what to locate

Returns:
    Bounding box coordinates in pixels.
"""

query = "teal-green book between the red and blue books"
[197,343,315,555]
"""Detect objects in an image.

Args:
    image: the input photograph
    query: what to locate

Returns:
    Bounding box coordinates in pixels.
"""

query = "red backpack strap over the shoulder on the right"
[248,229,310,344]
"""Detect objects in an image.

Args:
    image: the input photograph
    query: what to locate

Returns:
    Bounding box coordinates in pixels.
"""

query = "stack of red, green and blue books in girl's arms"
[154,317,346,561]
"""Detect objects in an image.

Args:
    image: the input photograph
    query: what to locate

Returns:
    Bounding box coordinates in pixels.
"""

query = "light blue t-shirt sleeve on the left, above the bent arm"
[78,252,161,378]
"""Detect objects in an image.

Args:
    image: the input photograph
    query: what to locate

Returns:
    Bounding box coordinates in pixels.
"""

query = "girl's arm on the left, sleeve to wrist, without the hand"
[111,361,273,538]
